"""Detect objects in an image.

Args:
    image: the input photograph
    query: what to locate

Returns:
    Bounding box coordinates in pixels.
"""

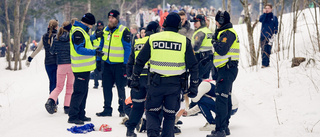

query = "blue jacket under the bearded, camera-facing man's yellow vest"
[99,23,131,64]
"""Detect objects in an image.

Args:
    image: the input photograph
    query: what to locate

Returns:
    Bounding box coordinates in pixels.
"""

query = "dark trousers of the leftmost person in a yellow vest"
[69,72,90,120]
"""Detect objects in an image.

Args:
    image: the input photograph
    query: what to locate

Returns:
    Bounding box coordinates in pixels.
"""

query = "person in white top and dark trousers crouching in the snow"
[183,79,238,131]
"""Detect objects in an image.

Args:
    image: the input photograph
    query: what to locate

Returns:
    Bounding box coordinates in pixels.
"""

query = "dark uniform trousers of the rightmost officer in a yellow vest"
[215,65,238,131]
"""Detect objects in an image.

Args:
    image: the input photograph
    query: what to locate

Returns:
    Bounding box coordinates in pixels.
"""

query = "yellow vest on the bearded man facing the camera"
[102,25,128,63]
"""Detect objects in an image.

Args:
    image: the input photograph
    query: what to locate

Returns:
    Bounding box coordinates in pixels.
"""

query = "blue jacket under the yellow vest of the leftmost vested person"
[72,21,96,56]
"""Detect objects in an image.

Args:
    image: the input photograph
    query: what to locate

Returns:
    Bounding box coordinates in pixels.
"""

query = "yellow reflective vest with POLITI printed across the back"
[149,31,187,76]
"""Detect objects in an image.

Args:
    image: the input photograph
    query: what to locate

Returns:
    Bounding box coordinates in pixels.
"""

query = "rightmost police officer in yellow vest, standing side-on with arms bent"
[207,11,239,137]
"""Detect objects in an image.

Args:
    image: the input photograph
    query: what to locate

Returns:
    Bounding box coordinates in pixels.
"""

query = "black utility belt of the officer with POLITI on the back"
[148,72,188,88]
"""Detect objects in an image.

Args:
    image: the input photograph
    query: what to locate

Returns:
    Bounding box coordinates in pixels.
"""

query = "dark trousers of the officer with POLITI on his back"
[146,76,182,137]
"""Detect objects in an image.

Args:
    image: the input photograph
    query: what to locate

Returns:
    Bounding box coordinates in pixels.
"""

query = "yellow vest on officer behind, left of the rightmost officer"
[191,27,213,53]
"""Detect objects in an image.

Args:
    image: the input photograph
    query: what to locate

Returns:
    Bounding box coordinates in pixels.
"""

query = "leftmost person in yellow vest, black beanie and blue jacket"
[68,13,103,124]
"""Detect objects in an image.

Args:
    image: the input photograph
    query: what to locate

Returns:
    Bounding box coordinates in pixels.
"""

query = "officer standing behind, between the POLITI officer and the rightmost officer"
[191,14,213,79]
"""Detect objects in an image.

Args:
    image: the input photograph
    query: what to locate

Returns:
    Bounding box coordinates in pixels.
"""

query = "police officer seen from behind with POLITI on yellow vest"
[131,13,199,137]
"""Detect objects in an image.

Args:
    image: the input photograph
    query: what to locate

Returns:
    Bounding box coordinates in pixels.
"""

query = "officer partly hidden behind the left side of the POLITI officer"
[126,21,161,137]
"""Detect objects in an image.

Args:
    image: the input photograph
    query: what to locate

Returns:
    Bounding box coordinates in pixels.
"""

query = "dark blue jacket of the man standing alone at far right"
[259,12,278,41]
